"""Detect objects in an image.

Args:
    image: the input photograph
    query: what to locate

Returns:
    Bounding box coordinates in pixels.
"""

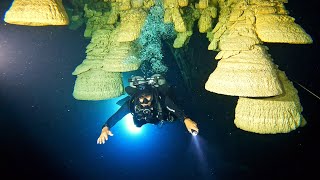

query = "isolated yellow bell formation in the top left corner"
[4,0,69,26]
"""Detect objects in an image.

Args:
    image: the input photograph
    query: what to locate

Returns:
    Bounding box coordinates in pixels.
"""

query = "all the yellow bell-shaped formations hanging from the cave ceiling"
[5,0,312,134]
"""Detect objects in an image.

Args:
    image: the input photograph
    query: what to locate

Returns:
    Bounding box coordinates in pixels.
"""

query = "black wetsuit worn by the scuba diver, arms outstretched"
[102,96,186,128]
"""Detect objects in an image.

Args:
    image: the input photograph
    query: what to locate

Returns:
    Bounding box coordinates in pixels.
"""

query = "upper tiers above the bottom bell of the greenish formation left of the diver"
[72,29,141,75]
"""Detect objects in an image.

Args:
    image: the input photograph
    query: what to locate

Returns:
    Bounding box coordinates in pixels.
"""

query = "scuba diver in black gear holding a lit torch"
[97,74,199,144]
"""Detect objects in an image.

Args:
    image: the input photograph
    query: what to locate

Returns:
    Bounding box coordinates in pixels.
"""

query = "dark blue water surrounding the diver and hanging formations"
[0,1,320,180]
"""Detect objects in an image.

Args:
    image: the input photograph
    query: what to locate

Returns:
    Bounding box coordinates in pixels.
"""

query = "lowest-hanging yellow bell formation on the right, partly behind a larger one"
[234,70,307,134]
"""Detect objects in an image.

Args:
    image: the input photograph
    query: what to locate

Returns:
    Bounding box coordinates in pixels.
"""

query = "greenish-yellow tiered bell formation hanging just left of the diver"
[72,29,141,100]
